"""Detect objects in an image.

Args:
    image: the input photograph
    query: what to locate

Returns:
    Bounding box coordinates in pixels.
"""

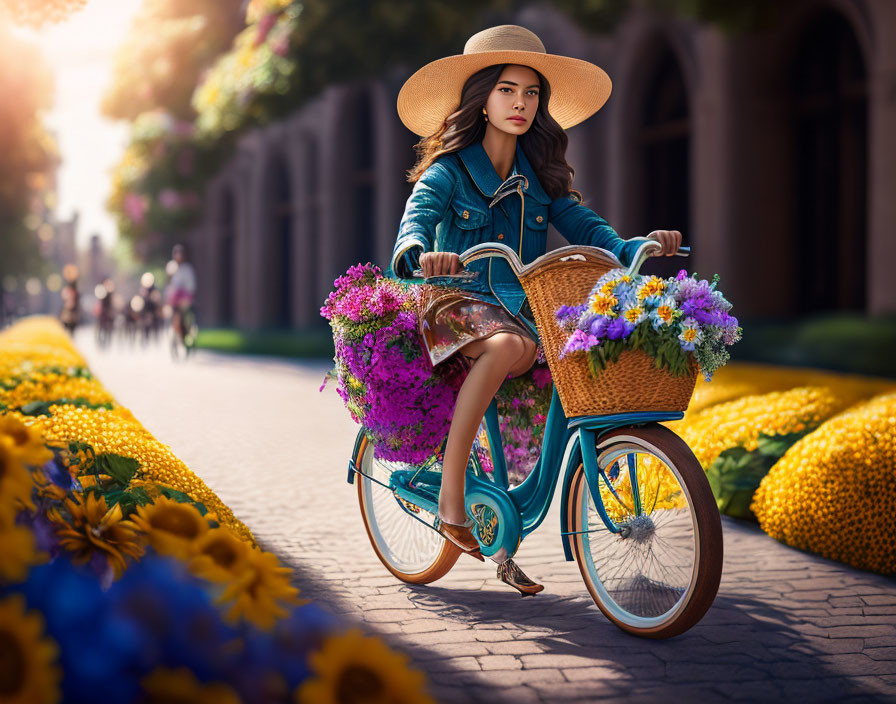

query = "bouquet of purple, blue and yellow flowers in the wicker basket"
[556,269,742,381]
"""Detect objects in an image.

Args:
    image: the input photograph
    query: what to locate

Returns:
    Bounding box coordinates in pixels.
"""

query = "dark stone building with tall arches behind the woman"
[192,0,896,329]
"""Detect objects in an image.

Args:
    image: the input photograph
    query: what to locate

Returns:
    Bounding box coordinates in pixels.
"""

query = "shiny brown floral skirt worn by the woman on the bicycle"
[418,284,538,366]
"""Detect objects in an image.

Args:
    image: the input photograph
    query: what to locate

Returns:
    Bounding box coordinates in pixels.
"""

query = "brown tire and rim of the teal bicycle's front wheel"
[566,424,723,639]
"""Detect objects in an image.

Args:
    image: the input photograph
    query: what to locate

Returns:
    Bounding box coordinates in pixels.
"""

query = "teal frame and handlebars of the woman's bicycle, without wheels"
[348,241,688,563]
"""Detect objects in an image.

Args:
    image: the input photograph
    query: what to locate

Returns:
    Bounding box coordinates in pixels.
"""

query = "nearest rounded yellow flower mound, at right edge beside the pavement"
[751,392,896,574]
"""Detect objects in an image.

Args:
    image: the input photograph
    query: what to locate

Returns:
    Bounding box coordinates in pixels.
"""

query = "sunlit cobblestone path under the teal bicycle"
[76,331,896,704]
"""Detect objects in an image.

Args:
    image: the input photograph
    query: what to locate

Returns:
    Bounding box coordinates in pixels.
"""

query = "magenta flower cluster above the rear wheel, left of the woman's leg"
[321,264,463,464]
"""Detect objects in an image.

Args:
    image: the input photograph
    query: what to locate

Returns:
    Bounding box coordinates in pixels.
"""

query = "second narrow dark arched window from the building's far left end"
[271,155,293,328]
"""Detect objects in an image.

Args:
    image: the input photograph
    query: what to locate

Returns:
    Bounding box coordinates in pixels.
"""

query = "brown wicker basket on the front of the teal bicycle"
[520,248,697,418]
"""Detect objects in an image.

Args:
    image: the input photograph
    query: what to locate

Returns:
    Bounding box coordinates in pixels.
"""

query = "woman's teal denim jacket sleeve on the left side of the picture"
[389,161,456,278]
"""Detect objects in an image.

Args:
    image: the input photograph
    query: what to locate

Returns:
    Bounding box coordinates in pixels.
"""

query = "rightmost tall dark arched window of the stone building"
[791,10,868,313]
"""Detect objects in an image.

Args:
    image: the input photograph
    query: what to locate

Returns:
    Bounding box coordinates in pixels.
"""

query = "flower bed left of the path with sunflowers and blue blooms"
[0,319,431,704]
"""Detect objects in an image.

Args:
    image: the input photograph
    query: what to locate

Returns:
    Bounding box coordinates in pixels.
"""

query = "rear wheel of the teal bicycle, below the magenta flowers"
[355,438,461,584]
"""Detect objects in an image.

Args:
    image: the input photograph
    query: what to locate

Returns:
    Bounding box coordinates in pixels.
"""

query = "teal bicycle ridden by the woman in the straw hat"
[348,241,723,638]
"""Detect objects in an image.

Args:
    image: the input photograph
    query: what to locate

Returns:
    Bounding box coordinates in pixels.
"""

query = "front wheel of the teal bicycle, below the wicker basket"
[567,425,722,638]
